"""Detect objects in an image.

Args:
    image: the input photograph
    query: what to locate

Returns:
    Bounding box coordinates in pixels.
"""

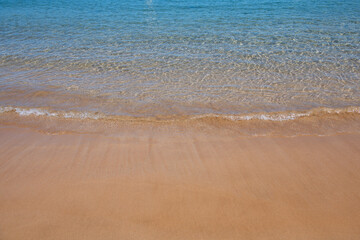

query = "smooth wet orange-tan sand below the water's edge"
[0,125,360,240]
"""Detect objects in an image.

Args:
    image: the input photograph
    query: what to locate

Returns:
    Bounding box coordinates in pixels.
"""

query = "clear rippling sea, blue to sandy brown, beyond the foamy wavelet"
[0,0,360,116]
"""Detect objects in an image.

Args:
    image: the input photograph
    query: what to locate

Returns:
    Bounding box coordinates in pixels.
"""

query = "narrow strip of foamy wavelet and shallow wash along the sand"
[0,106,360,137]
